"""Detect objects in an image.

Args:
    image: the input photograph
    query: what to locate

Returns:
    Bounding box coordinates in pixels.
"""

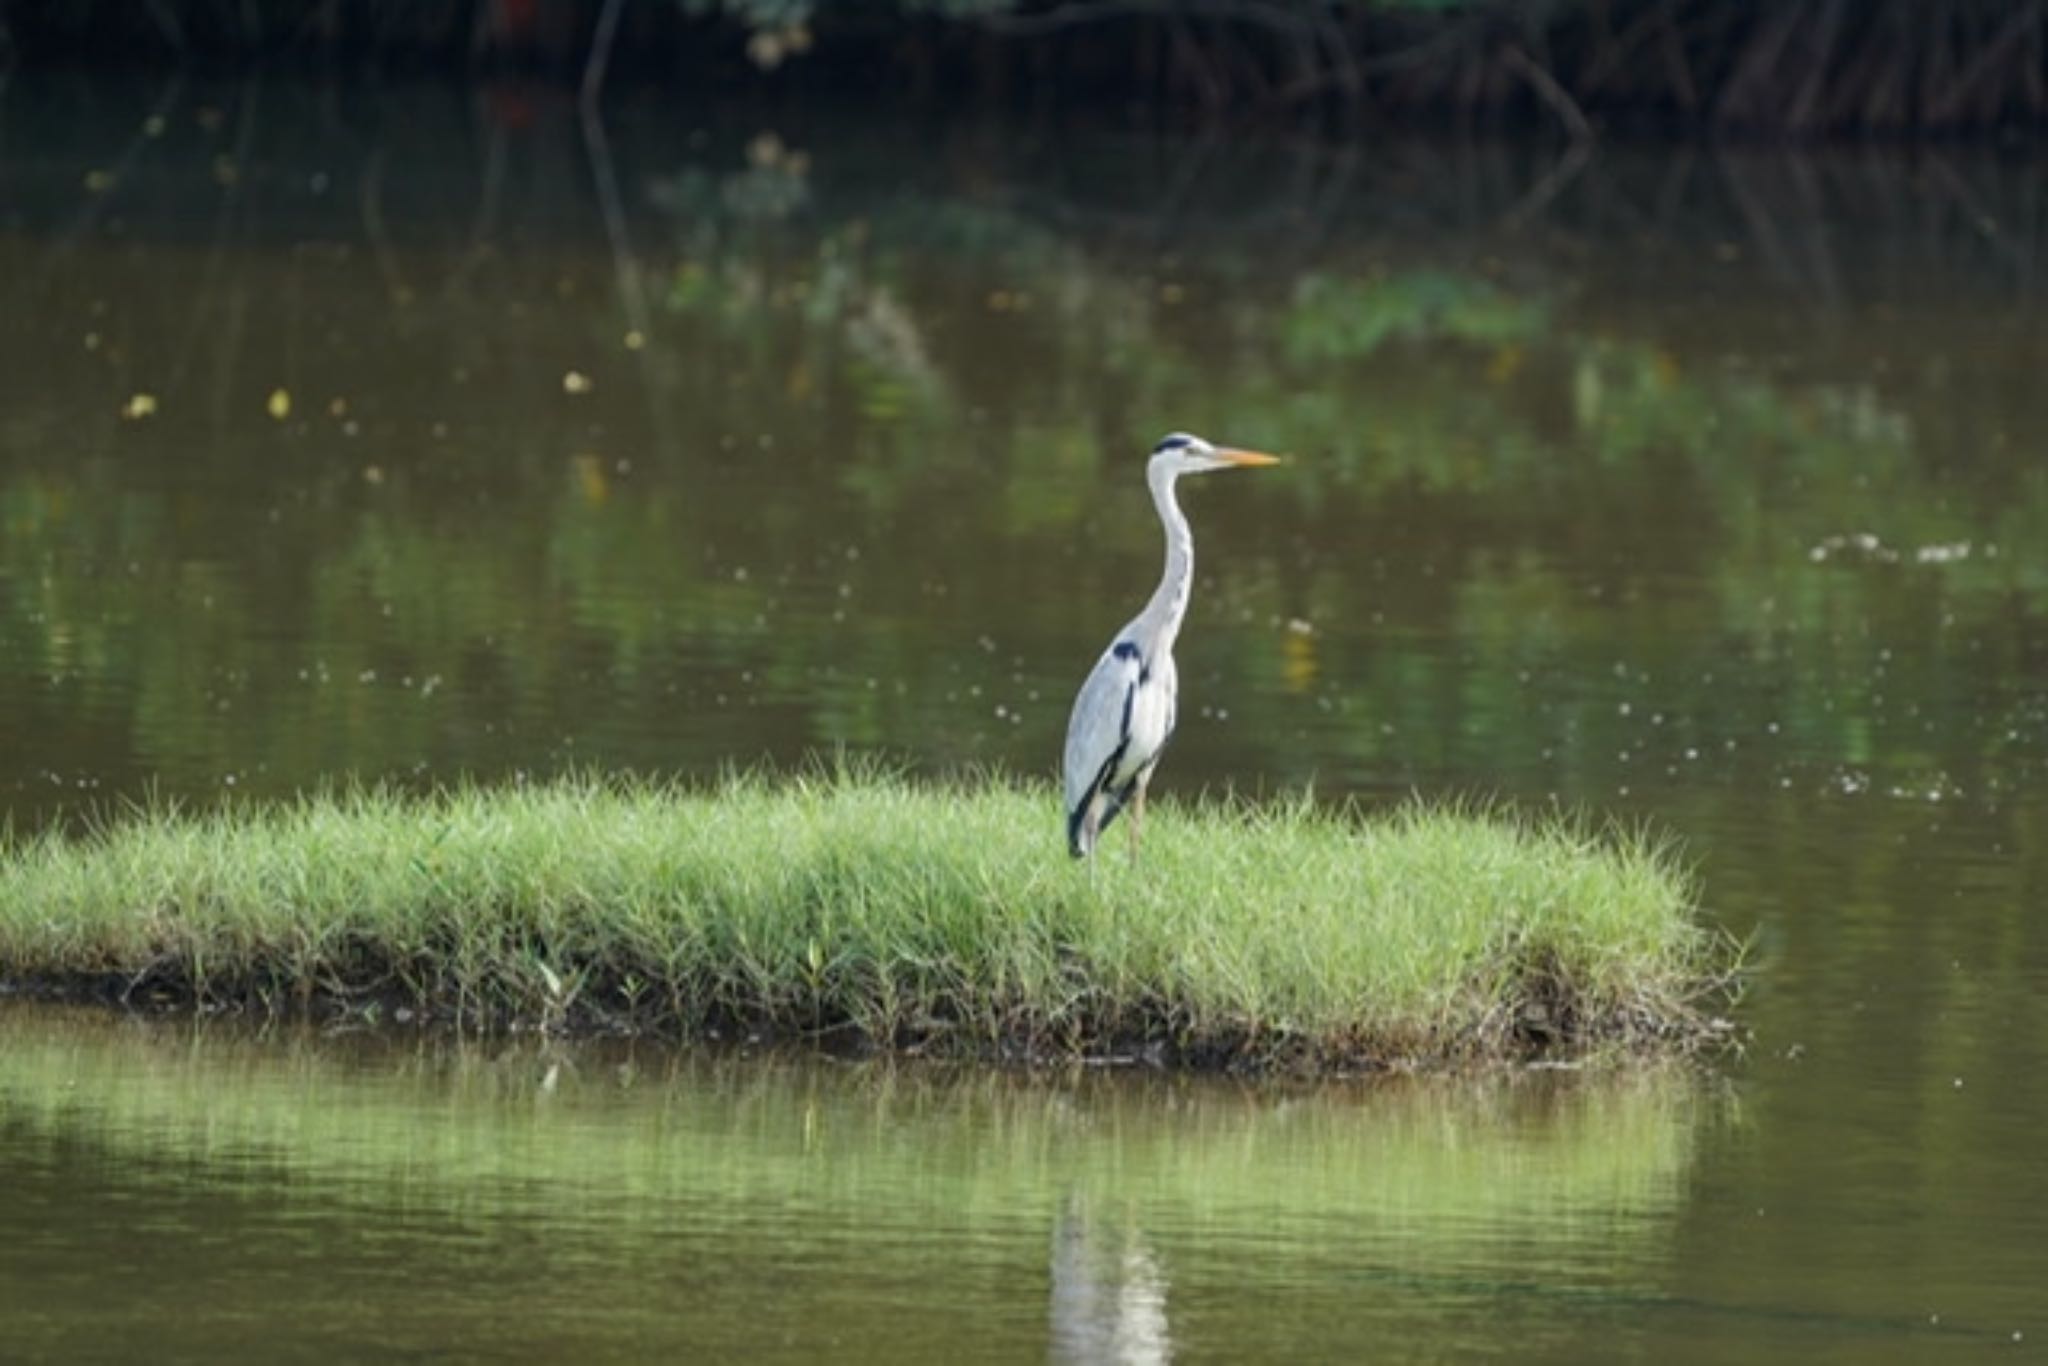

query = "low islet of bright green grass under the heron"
[0,770,1733,1069]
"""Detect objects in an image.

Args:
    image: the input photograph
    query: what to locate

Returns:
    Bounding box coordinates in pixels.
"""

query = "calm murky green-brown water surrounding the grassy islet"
[0,78,2048,1362]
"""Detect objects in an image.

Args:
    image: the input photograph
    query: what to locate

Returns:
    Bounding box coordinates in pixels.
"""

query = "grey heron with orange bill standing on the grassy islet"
[1063,432,1280,858]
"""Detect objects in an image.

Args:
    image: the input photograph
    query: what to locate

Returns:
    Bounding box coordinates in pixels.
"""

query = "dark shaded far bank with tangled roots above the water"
[0,0,2048,137]
